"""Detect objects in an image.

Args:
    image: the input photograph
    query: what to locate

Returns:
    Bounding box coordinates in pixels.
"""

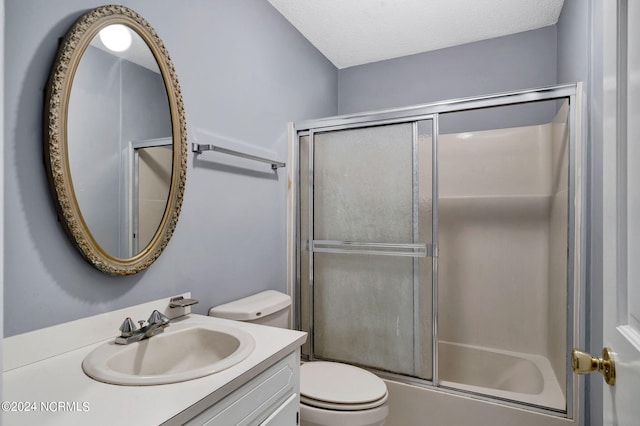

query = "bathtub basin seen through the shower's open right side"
[438,341,566,410]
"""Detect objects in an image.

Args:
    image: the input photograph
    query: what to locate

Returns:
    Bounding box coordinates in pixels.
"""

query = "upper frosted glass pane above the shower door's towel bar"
[314,124,413,243]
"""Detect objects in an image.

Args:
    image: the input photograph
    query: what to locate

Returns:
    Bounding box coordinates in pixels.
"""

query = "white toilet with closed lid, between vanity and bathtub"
[209,290,389,426]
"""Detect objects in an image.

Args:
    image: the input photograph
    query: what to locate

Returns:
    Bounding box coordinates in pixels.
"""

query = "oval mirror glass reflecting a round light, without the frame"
[67,24,173,258]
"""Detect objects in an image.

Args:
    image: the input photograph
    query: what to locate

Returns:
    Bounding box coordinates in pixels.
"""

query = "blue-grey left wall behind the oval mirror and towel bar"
[3,0,337,336]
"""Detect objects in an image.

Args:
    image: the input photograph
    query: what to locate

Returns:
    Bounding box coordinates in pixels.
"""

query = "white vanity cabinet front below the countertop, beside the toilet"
[180,351,300,426]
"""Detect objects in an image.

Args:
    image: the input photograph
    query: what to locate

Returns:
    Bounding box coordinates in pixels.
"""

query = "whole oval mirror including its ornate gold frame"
[44,5,187,275]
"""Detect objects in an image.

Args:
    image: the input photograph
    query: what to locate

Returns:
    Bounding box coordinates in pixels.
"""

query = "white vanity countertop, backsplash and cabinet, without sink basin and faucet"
[0,300,306,426]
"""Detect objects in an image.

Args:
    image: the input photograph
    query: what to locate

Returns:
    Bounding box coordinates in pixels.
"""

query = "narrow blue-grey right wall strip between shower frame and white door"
[557,0,607,425]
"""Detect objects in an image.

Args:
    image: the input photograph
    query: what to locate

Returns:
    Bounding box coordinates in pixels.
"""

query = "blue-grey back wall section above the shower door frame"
[338,26,556,114]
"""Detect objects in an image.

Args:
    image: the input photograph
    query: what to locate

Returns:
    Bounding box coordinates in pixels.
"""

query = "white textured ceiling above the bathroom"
[269,0,564,68]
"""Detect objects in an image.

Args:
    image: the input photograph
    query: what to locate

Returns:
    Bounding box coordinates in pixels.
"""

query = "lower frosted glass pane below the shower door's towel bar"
[314,253,413,374]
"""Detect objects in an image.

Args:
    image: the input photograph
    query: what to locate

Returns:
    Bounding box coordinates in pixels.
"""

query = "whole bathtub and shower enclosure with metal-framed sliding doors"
[290,84,584,426]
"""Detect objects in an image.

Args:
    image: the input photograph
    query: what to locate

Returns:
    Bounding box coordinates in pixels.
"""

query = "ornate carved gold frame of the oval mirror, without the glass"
[44,5,187,275]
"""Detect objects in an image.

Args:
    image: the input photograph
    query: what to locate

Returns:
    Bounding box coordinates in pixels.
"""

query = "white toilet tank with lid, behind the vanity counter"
[209,290,291,328]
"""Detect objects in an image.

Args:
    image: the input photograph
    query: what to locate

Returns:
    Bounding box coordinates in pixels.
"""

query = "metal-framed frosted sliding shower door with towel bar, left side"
[299,119,434,380]
